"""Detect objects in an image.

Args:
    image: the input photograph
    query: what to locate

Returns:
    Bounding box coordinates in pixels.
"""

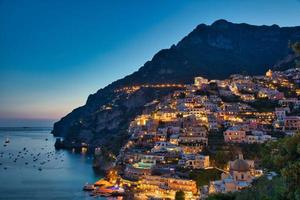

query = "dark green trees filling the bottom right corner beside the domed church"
[208,133,300,200]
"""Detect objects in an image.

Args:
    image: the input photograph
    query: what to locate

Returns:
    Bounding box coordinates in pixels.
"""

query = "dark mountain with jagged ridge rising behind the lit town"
[52,20,300,152]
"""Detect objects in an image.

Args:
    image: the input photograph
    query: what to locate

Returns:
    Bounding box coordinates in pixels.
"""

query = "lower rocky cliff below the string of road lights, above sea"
[53,88,174,153]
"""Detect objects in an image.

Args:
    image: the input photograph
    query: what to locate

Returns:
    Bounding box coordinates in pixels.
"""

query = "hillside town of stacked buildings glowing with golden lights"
[86,68,300,200]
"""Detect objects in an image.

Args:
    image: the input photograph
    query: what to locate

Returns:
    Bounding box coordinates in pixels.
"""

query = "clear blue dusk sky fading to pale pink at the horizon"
[0,0,300,126]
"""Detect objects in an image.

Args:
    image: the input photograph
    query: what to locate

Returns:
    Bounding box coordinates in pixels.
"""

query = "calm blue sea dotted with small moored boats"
[0,128,103,200]
